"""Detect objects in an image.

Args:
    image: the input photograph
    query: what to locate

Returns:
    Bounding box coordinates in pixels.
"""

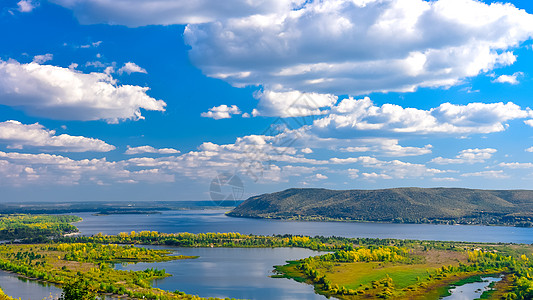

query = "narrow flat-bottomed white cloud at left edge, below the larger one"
[0,120,115,152]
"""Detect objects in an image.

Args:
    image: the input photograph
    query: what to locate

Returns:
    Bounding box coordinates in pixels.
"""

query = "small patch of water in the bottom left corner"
[0,271,61,300]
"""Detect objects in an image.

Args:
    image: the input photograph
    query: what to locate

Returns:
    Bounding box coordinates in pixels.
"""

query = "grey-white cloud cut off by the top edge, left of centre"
[50,0,304,27]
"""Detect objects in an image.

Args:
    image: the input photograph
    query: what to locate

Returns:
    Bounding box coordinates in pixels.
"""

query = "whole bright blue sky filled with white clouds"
[0,0,533,202]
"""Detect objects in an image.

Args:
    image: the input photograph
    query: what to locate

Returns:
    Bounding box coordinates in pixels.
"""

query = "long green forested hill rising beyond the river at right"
[228,188,533,226]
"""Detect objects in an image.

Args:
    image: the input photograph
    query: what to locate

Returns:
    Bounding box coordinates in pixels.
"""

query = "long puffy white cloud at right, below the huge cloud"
[313,97,530,135]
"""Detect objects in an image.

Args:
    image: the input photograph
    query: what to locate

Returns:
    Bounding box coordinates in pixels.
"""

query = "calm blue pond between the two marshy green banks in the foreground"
[115,247,325,300]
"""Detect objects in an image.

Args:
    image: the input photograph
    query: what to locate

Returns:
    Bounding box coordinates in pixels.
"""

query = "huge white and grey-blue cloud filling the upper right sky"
[184,0,533,95]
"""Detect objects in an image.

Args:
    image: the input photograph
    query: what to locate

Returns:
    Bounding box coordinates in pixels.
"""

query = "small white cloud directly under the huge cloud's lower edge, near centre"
[252,90,337,118]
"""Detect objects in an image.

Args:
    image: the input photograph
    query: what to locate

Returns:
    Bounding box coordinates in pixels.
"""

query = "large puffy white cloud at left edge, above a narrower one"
[0,60,166,123]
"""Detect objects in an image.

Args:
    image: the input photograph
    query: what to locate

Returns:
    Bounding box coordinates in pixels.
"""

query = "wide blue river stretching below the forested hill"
[75,210,533,244]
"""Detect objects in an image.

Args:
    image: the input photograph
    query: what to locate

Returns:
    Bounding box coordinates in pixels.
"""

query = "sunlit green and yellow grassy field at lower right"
[276,245,533,299]
